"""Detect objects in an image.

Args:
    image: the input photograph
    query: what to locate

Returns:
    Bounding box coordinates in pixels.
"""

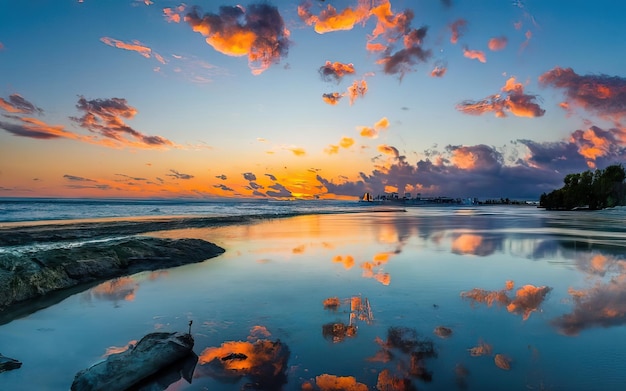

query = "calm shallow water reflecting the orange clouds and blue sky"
[0,206,626,390]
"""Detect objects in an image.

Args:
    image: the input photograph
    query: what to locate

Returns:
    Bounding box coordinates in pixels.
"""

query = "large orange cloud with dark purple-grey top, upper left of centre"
[185,3,290,75]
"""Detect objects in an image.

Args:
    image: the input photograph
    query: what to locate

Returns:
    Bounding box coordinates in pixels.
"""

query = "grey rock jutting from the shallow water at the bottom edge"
[71,333,194,391]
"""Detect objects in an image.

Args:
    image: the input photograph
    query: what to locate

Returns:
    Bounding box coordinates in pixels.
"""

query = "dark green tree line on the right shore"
[539,164,626,210]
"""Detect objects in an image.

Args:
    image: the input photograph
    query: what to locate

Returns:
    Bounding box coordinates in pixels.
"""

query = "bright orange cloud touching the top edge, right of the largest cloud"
[298,0,370,34]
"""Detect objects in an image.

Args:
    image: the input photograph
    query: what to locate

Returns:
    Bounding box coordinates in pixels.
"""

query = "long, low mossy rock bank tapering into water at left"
[0,237,224,318]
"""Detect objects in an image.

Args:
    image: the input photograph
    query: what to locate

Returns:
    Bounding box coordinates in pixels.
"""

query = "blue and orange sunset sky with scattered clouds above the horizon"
[0,0,626,199]
